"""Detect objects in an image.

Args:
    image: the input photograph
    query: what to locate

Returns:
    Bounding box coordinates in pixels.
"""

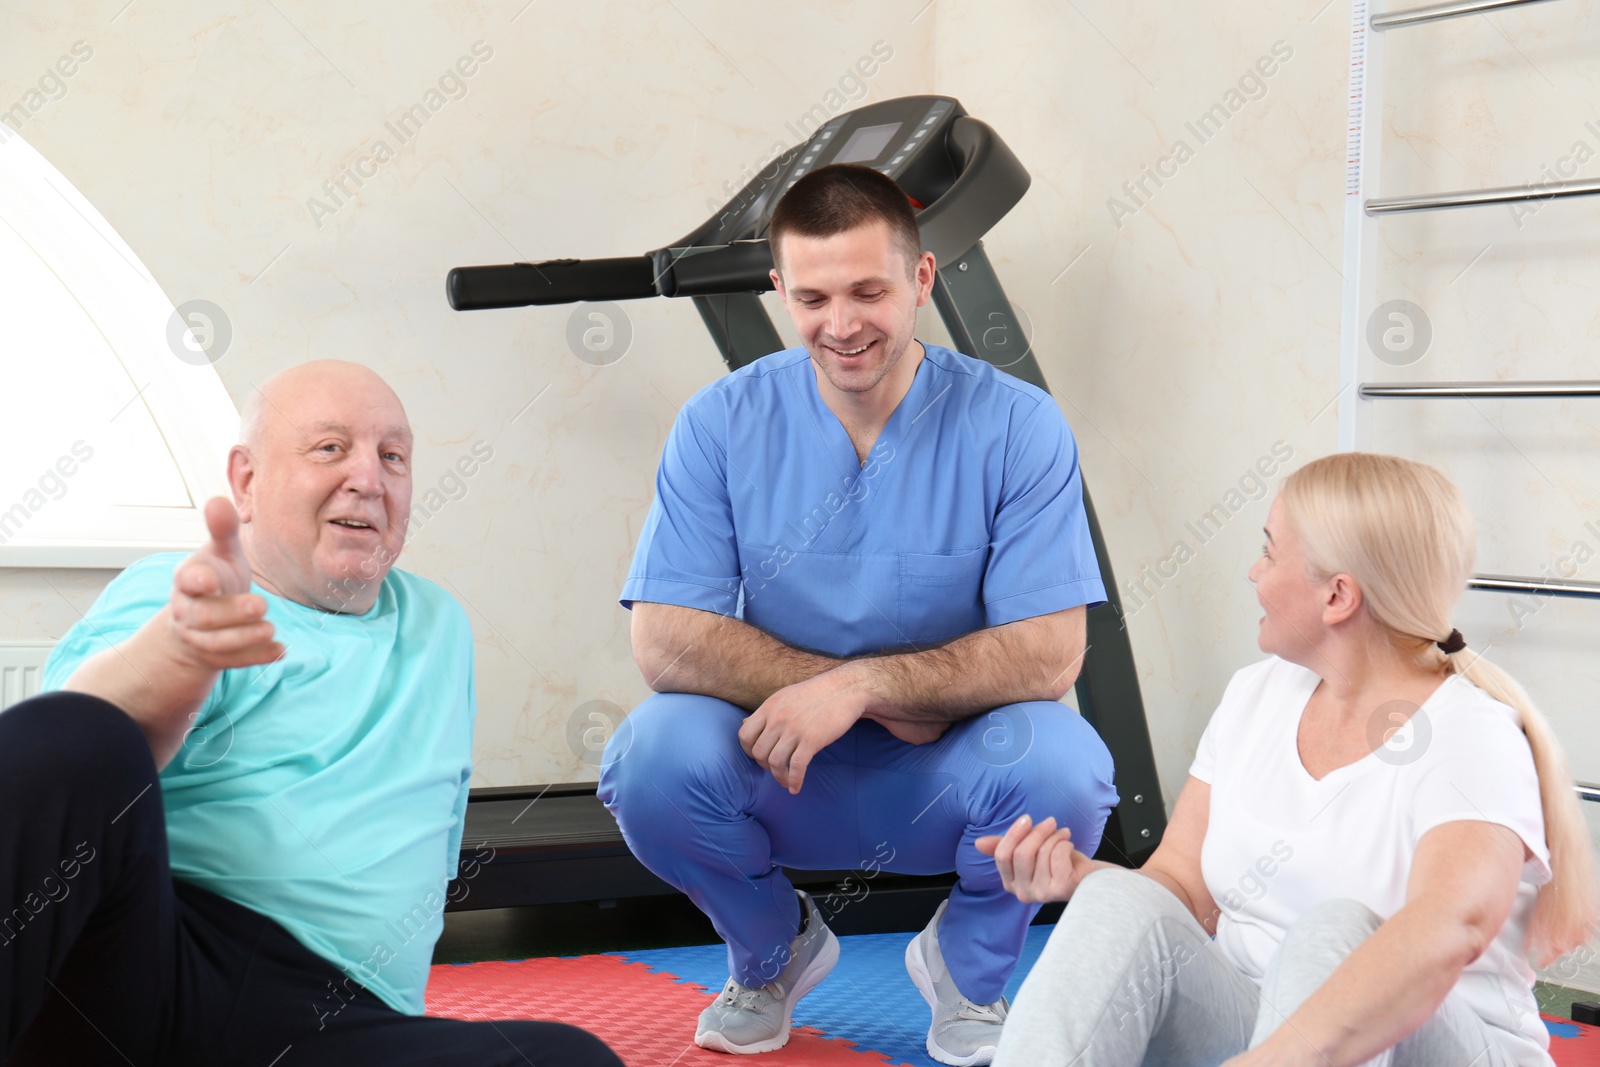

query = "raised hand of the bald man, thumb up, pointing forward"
[168,496,283,670]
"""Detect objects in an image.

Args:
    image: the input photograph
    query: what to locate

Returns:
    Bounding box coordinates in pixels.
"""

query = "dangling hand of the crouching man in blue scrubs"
[739,670,867,793]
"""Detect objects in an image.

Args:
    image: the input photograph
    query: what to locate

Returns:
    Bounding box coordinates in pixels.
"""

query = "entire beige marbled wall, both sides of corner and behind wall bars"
[0,0,1600,857]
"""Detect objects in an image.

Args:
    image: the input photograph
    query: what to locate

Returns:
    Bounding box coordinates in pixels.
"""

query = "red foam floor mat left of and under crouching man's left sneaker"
[427,955,908,1067]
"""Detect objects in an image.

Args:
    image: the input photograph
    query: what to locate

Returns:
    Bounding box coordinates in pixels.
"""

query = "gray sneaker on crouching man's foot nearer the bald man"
[694,889,838,1054]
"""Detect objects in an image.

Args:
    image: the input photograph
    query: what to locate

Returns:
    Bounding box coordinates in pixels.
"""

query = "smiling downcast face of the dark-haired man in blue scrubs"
[773,221,934,406]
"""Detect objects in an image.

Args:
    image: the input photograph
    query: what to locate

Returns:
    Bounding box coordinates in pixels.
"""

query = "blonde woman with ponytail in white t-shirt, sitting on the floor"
[978,453,1597,1067]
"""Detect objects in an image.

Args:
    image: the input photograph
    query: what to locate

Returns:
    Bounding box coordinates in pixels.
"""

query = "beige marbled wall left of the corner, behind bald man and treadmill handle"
[0,0,934,785]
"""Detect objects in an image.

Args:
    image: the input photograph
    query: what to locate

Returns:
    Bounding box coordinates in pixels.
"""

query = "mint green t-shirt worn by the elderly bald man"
[43,553,477,1014]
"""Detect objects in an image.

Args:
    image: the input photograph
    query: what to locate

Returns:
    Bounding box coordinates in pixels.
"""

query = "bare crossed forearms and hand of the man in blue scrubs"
[632,601,1086,793]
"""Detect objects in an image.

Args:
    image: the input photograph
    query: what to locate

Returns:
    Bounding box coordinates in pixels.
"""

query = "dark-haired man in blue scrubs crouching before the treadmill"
[600,166,1117,1064]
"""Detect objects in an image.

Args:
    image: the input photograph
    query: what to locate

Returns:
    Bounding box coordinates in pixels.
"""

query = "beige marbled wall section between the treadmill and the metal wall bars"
[938,2,1349,805]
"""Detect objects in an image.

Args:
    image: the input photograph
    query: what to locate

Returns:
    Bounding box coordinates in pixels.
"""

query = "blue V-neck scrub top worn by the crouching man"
[621,344,1106,656]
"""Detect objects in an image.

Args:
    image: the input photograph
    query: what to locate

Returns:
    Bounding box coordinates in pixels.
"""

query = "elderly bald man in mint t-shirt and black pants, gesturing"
[0,362,621,1067]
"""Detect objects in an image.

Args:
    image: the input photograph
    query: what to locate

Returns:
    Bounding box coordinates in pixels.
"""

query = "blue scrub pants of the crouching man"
[600,693,1117,1005]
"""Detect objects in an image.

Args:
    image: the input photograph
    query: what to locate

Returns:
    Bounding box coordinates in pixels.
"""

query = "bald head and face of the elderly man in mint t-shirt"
[229,360,411,614]
